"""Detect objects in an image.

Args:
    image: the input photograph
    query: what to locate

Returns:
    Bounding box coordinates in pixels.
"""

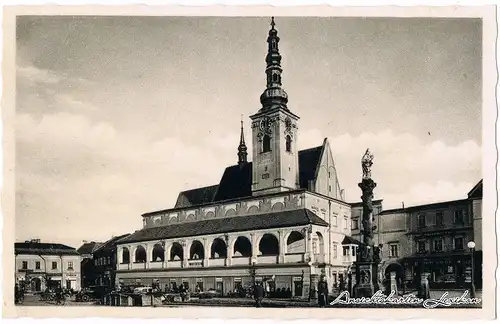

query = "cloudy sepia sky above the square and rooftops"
[15,16,482,247]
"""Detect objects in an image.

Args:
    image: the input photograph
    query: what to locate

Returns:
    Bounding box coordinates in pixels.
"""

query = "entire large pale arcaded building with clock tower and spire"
[116,20,355,297]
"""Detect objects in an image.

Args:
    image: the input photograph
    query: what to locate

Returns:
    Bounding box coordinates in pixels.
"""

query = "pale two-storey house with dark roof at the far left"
[15,240,80,292]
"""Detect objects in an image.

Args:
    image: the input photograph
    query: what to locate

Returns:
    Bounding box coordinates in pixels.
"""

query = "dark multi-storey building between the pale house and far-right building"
[404,199,474,286]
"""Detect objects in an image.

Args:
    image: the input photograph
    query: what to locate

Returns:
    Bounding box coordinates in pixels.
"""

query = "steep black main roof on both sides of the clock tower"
[174,145,323,208]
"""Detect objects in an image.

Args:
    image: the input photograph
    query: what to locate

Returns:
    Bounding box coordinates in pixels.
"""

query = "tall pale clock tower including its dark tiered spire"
[250,17,299,196]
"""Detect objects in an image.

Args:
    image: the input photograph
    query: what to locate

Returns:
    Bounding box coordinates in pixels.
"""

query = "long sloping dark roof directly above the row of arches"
[117,209,328,244]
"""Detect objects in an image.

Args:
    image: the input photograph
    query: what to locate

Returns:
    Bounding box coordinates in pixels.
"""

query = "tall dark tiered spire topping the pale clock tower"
[260,17,288,110]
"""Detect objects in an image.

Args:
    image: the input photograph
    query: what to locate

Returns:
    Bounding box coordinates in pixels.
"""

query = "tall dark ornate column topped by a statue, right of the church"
[353,149,380,298]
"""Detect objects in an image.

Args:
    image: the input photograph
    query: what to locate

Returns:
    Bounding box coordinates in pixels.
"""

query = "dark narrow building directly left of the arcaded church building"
[92,234,130,288]
